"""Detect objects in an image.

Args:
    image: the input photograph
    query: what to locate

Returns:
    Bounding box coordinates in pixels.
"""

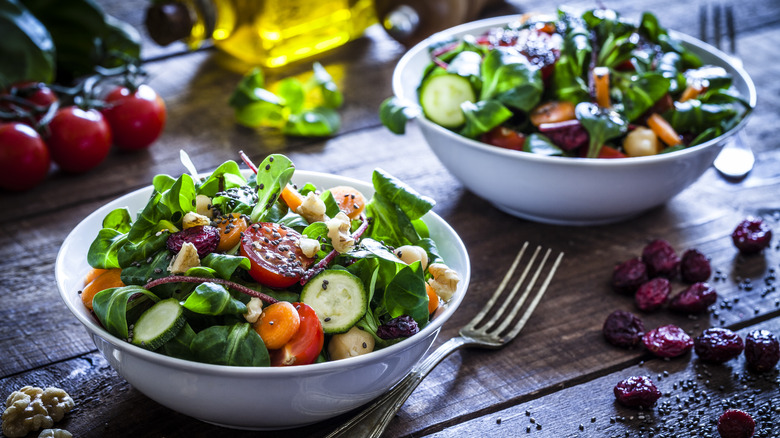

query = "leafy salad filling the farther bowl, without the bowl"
[380,8,752,158]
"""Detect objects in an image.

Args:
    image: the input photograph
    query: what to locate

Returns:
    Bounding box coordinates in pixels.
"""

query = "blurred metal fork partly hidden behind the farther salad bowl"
[699,3,756,179]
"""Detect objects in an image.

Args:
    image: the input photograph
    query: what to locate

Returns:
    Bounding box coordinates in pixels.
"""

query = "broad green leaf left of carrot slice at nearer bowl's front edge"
[190,323,271,367]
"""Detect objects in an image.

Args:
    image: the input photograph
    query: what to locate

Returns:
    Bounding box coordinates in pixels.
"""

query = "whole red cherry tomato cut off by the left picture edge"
[0,122,51,191]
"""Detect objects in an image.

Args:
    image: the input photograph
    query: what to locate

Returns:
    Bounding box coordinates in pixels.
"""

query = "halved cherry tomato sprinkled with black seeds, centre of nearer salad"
[241,222,313,288]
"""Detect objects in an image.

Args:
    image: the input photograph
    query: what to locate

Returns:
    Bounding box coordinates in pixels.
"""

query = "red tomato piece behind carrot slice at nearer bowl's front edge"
[268,303,325,366]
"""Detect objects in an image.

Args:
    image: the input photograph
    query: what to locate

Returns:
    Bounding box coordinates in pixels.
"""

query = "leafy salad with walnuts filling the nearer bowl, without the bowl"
[80,153,459,366]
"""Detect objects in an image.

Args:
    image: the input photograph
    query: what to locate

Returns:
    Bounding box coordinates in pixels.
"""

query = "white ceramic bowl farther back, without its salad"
[392,16,756,225]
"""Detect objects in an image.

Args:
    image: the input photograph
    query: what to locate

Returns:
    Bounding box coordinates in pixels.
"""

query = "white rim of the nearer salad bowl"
[55,168,471,377]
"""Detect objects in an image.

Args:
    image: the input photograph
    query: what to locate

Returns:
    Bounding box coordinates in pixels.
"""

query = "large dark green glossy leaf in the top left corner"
[0,0,56,89]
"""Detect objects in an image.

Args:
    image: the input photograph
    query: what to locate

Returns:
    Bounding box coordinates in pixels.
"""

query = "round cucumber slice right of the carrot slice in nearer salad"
[301,269,368,334]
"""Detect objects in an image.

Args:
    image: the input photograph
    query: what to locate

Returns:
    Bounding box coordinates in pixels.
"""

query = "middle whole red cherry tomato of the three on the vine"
[46,106,111,172]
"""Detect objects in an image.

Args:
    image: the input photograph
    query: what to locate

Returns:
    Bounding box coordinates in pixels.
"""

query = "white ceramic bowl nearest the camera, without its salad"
[55,170,471,430]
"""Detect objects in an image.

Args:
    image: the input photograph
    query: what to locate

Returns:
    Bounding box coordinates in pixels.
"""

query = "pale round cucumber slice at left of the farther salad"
[420,73,477,128]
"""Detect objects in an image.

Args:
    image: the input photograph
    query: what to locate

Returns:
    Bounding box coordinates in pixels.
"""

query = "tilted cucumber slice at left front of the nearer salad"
[132,298,184,350]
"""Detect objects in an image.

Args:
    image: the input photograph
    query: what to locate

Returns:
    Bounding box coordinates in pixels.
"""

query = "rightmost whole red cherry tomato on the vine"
[103,85,167,150]
